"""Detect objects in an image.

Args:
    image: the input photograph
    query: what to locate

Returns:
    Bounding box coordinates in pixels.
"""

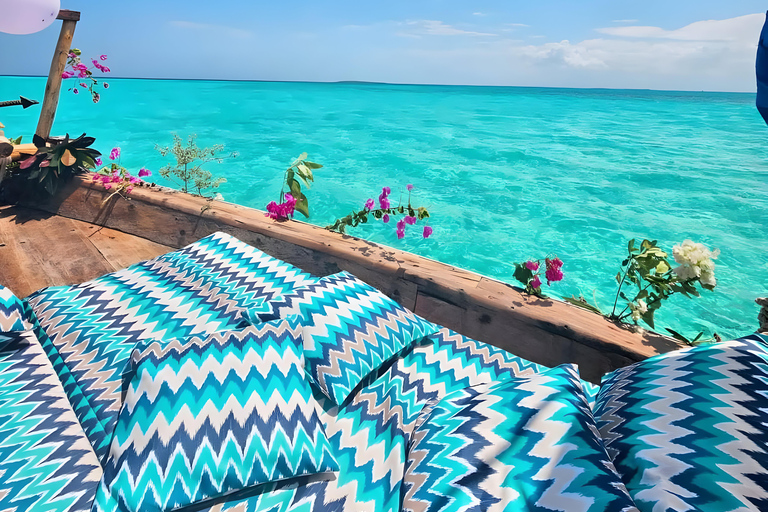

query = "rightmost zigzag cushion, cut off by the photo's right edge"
[595,335,768,512]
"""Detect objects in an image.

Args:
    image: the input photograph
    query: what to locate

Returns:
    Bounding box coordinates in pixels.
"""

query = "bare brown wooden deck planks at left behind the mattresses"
[0,206,174,297]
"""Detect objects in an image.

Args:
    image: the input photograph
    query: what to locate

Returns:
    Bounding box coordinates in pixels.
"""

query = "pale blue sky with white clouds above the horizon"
[0,0,766,92]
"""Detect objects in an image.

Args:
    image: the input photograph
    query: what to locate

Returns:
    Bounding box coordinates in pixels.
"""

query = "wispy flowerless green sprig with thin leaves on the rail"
[155,133,237,197]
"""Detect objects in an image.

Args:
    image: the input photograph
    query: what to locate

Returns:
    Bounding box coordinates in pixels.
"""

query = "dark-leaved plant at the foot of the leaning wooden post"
[19,134,101,196]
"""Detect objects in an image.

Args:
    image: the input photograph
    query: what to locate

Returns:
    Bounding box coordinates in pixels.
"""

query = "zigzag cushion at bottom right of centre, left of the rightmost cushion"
[403,365,636,512]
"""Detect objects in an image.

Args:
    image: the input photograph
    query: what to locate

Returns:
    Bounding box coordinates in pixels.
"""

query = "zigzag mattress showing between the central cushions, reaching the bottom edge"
[201,329,546,512]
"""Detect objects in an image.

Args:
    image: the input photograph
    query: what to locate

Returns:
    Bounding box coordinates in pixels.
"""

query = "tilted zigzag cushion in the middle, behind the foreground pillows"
[244,272,440,404]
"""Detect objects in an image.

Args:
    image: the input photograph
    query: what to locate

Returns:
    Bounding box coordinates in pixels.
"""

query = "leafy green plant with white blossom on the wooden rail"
[563,239,720,344]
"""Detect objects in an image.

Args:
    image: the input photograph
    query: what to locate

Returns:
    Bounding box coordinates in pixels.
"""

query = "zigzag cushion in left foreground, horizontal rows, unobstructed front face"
[95,317,339,512]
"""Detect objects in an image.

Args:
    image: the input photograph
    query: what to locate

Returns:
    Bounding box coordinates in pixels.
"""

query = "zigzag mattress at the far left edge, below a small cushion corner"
[0,331,101,512]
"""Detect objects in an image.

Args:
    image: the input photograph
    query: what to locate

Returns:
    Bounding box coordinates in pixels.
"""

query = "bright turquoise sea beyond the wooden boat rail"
[0,77,768,337]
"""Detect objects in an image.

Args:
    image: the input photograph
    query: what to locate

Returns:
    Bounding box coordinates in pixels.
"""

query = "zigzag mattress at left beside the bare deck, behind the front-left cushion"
[27,233,315,460]
